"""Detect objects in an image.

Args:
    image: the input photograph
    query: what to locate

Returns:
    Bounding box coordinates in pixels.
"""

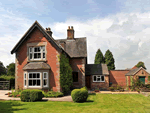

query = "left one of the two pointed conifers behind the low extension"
[94,49,105,64]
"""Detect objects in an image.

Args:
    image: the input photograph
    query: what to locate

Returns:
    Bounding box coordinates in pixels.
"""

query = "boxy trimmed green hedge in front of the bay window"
[20,89,43,102]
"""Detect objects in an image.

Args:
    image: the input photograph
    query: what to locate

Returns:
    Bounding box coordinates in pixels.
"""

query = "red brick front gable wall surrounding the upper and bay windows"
[16,28,60,91]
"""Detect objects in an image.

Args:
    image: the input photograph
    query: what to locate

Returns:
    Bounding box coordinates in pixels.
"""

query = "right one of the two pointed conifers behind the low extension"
[105,49,115,70]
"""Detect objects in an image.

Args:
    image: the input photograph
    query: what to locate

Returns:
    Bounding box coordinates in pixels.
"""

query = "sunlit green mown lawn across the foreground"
[0,94,150,113]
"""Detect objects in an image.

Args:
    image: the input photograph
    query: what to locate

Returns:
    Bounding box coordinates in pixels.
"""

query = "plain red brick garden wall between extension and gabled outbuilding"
[109,70,129,86]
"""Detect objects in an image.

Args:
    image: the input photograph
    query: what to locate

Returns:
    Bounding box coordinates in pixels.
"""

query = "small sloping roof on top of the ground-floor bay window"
[23,62,51,70]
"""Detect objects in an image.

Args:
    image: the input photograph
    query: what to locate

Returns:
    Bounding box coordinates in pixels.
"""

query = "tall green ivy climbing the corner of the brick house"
[60,53,73,95]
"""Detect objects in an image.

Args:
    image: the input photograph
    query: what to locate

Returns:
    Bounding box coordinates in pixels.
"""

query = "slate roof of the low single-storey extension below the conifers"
[85,64,109,75]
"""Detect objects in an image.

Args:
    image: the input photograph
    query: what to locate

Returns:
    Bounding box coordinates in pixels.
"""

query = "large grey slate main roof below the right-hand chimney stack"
[56,37,87,58]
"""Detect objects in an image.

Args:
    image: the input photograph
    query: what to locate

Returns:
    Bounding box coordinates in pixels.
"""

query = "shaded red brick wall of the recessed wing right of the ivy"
[70,58,85,87]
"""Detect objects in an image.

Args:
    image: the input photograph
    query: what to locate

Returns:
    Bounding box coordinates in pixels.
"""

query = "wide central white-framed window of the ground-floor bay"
[28,72,41,87]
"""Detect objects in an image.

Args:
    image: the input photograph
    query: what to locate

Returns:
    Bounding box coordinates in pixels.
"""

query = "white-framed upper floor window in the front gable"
[29,46,45,60]
